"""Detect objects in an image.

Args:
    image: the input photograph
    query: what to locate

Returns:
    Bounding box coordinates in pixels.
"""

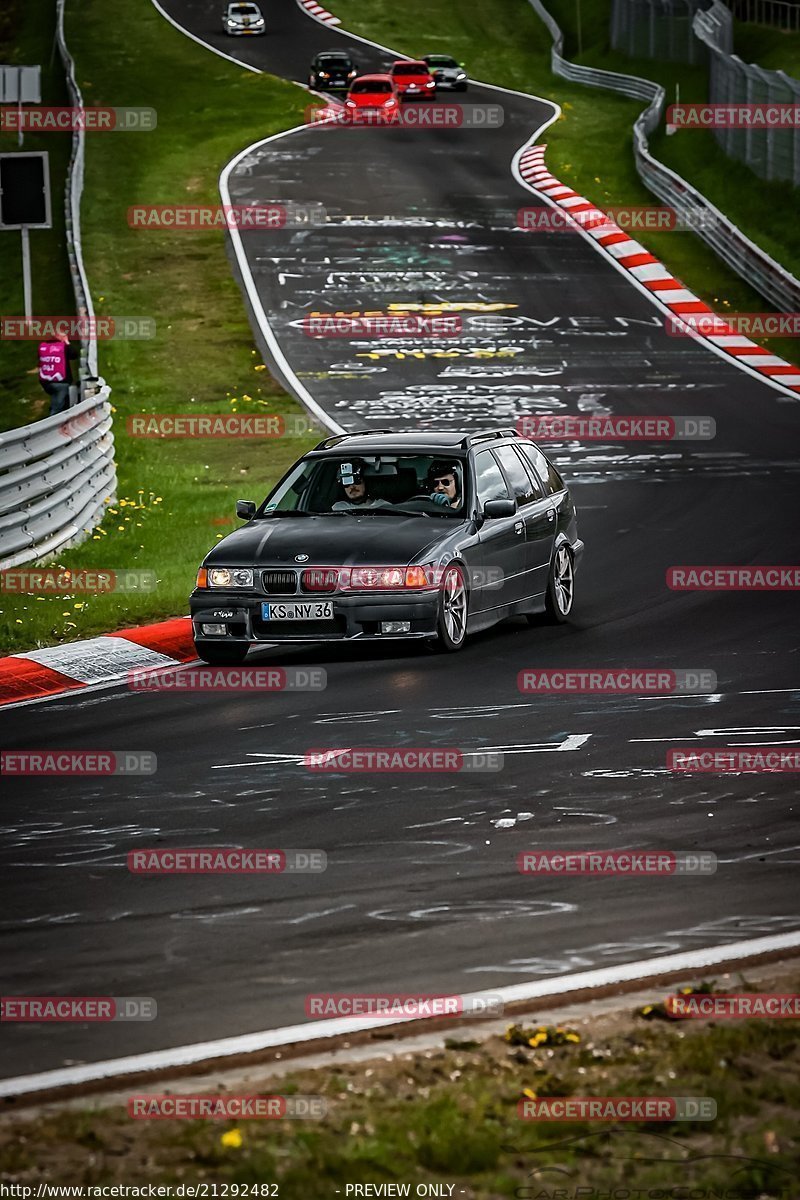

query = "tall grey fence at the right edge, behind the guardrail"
[694,0,800,185]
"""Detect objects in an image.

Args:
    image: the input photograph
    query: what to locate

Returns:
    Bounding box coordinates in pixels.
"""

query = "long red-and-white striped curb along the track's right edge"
[515,145,800,395]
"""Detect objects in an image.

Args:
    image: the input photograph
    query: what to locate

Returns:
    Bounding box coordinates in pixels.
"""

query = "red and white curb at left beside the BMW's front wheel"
[0,617,197,707]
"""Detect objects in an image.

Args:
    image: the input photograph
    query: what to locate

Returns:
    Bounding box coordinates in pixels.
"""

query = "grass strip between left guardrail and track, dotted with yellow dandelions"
[0,0,326,652]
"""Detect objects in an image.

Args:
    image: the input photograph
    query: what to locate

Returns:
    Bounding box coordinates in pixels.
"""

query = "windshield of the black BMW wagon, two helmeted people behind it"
[258,452,465,518]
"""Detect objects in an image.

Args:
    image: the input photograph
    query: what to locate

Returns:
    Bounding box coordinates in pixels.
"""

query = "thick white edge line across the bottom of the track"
[0,930,800,1098]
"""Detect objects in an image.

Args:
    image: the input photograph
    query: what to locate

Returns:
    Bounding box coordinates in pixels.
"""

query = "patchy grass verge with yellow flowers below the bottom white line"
[0,988,800,1200]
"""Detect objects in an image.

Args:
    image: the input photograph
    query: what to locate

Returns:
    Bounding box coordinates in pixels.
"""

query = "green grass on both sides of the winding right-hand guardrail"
[332,0,800,361]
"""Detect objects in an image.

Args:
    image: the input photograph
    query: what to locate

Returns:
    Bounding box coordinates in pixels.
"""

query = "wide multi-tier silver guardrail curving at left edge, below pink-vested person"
[0,380,116,569]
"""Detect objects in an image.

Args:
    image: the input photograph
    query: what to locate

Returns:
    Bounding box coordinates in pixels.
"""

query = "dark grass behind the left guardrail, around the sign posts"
[0,0,74,431]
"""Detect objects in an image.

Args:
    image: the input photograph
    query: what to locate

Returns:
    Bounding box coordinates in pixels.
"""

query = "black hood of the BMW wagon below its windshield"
[204,514,453,566]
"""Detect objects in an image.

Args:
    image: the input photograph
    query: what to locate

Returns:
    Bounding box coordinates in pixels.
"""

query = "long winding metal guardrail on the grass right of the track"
[529,0,800,312]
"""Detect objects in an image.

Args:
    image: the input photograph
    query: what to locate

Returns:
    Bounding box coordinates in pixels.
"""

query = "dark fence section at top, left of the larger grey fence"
[610,0,708,64]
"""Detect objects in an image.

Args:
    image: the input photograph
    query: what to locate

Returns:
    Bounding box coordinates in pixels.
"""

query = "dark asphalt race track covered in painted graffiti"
[0,0,800,1076]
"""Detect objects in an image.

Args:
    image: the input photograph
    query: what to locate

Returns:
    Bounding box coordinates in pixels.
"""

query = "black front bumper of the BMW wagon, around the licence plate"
[190,588,439,644]
